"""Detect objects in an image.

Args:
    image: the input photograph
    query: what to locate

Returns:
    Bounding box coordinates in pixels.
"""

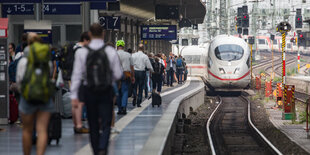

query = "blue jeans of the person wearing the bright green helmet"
[117,80,130,111]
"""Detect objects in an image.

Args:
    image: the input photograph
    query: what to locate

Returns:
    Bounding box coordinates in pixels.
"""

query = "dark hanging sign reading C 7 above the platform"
[99,16,121,30]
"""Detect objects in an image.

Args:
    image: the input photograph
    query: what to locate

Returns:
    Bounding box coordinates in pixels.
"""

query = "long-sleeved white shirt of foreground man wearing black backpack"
[70,39,123,99]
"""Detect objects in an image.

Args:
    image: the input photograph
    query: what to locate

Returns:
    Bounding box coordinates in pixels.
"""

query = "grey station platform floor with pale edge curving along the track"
[0,77,204,155]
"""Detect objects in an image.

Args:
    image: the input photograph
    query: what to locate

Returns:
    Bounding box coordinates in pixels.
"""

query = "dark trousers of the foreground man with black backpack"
[85,87,113,155]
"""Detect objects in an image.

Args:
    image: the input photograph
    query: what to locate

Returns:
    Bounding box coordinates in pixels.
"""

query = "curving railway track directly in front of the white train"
[206,96,282,155]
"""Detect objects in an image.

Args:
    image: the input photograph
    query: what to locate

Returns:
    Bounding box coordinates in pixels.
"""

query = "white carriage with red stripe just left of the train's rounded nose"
[181,45,208,76]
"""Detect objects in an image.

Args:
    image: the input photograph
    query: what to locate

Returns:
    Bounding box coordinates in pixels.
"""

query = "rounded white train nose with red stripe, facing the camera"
[205,35,251,90]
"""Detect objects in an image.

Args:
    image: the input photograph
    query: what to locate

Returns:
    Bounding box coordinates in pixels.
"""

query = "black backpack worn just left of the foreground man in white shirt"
[59,44,81,81]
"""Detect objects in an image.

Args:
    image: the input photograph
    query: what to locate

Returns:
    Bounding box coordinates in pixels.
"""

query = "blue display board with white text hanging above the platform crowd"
[141,25,177,40]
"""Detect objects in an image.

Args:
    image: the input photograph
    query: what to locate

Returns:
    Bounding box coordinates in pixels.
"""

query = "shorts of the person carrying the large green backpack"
[18,97,55,114]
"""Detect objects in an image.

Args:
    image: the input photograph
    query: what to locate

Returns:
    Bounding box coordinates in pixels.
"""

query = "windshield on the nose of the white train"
[215,44,244,61]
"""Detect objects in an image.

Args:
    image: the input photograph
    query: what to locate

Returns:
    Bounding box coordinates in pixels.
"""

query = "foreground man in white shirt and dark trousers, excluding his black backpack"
[70,23,123,154]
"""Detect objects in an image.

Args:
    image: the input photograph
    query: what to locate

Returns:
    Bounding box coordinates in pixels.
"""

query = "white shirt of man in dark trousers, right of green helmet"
[132,51,153,72]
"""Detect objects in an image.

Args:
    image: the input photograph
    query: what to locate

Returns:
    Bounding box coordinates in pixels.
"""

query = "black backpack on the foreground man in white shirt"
[85,45,112,93]
